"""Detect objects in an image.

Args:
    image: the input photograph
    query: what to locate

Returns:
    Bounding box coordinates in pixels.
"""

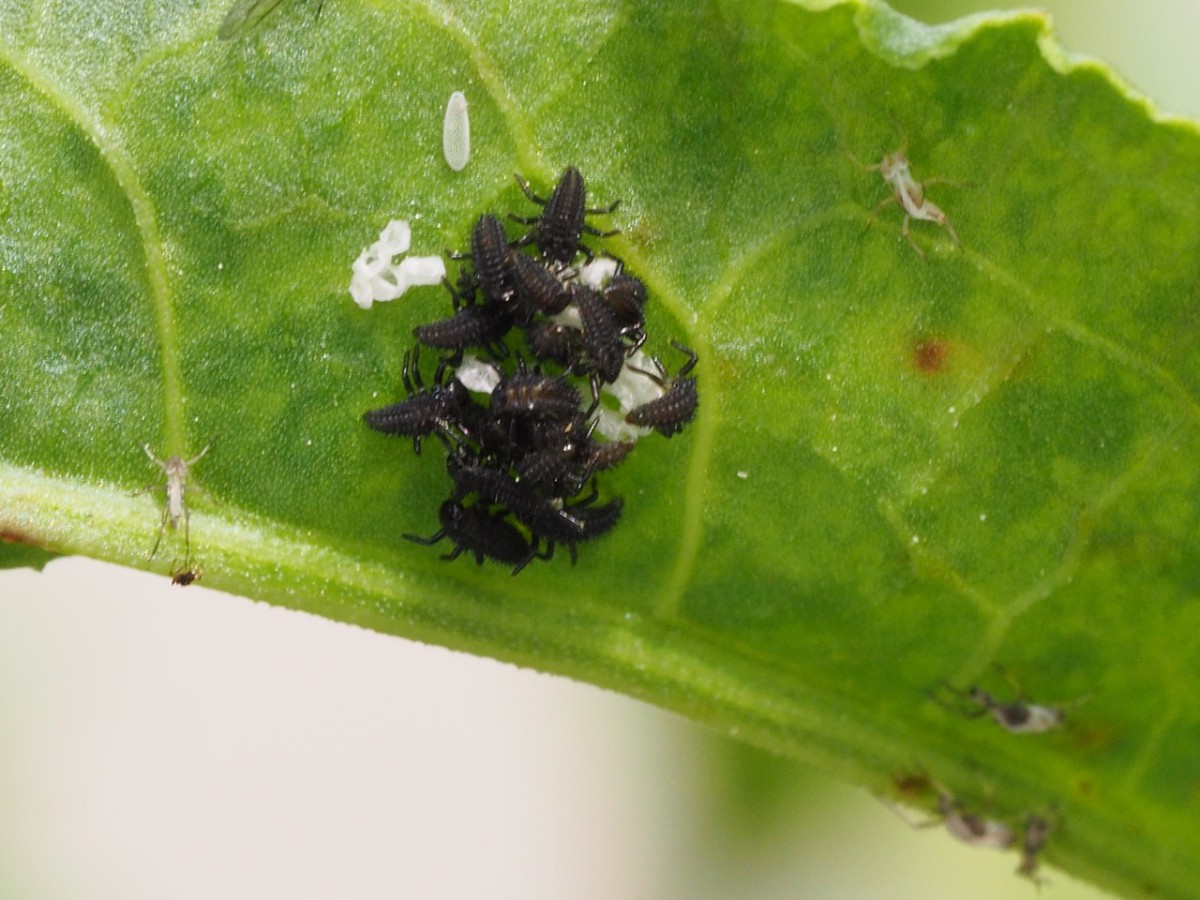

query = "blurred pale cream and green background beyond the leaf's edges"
[0,0,1200,900]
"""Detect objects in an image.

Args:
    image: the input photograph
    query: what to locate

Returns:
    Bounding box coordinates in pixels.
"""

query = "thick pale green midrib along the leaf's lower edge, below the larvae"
[0,453,1192,894]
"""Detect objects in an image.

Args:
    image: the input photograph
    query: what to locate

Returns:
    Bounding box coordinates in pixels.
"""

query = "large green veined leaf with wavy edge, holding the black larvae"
[0,0,1200,896]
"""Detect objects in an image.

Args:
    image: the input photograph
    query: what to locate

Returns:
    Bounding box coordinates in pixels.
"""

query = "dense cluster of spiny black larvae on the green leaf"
[364,168,697,575]
